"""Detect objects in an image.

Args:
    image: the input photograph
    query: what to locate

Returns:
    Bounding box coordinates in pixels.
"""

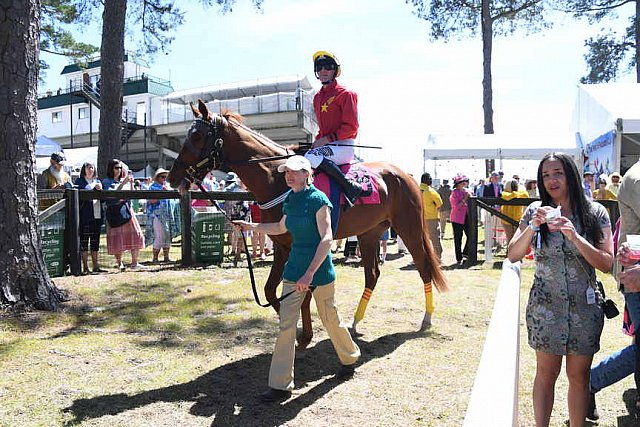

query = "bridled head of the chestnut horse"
[168,99,226,192]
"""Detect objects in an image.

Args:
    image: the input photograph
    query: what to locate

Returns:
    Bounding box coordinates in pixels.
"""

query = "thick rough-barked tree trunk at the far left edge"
[0,0,62,310]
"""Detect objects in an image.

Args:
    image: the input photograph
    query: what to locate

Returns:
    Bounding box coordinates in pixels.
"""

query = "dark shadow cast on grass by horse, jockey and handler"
[63,332,432,426]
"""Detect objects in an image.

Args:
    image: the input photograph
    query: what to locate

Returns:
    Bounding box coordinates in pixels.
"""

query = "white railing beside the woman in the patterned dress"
[464,260,520,427]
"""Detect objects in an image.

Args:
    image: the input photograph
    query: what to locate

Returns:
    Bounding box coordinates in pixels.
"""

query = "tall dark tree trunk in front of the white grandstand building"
[96,0,127,177]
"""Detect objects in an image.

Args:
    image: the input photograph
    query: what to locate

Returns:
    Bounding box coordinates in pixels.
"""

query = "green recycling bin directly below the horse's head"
[191,207,224,264]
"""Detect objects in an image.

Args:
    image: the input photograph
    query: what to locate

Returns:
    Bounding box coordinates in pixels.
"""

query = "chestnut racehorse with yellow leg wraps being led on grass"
[169,100,448,349]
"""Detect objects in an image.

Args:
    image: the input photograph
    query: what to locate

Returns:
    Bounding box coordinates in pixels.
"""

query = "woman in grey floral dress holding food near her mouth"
[508,153,613,426]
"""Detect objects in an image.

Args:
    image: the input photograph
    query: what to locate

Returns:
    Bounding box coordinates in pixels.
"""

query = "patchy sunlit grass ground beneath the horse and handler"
[0,231,633,427]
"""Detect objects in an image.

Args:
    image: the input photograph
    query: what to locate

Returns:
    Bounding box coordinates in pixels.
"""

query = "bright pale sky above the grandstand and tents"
[40,0,634,180]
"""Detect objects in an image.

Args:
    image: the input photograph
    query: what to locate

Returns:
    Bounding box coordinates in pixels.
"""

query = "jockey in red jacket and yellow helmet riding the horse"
[304,51,362,205]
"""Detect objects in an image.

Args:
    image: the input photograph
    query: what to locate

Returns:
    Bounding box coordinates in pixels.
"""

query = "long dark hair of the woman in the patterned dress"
[538,153,604,244]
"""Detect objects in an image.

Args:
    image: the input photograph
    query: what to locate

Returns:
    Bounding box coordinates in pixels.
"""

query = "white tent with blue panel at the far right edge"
[572,83,640,173]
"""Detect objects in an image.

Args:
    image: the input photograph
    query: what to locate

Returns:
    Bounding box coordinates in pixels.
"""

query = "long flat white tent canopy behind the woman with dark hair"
[424,133,581,163]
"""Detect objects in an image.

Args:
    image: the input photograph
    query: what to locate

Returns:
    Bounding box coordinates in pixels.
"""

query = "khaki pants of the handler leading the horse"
[269,281,360,390]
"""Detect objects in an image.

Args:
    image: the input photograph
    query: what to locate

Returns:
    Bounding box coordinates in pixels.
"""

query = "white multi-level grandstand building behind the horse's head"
[38,55,317,175]
